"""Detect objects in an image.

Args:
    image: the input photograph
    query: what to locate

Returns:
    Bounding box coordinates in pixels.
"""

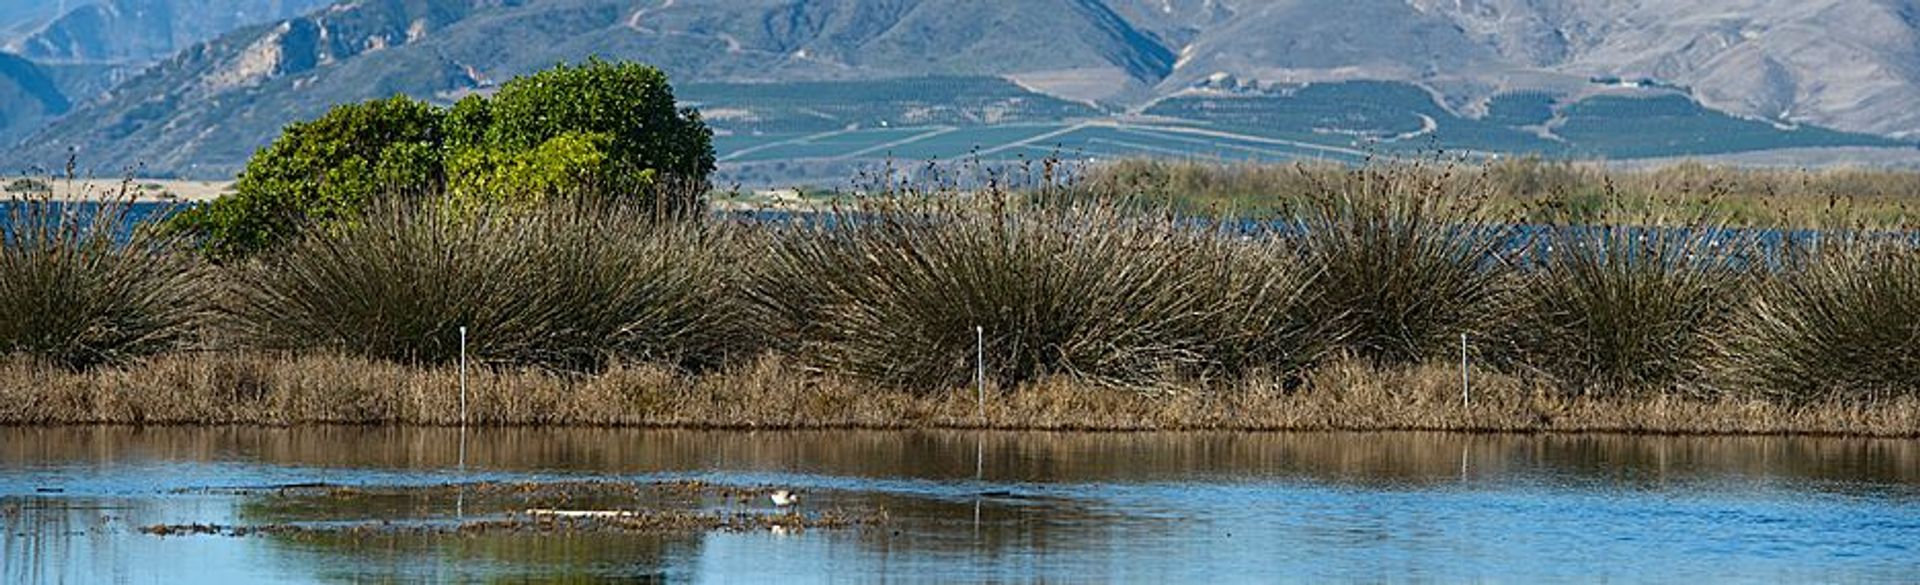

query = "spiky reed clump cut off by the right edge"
[1724,236,1920,403]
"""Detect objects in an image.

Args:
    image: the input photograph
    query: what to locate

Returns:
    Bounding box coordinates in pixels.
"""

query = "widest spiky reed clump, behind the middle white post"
[753,194,1319,389]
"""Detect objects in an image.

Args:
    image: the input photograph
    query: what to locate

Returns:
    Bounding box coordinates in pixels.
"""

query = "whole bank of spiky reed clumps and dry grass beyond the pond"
[0,160,1920,435]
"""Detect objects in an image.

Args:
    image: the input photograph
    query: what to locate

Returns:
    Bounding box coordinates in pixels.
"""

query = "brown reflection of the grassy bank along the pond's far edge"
[0,428,1920,487]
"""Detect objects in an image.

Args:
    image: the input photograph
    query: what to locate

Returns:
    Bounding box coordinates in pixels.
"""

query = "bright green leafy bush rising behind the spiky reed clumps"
[173,59,714,259]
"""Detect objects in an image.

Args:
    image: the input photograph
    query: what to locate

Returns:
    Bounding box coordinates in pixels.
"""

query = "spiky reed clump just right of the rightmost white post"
[1501,222,1753,393]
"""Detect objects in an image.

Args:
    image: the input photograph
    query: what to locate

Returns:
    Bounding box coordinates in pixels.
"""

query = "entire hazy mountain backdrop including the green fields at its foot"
[0,0,1920,176]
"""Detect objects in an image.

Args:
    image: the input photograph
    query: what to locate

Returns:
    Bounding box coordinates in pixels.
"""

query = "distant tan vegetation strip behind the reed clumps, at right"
[1085,157,1920,228]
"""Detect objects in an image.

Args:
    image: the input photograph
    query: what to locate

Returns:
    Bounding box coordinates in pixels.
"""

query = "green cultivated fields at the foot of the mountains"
[698,77,1920,184]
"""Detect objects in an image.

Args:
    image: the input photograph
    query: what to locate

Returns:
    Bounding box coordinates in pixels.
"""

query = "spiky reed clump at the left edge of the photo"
[0,184,211,368]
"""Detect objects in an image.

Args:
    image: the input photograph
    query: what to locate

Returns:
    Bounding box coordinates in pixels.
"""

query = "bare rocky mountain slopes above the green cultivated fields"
[10,0,1920,176]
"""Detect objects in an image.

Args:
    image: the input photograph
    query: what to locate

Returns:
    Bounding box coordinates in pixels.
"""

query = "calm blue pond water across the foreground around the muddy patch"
[0,428,1920,583]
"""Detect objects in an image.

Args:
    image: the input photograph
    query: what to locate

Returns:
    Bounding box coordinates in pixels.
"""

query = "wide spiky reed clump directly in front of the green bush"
[228,203,751,370]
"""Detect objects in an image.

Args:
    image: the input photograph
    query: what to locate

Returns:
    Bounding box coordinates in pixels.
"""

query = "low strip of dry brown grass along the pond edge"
[0,353,1920,437]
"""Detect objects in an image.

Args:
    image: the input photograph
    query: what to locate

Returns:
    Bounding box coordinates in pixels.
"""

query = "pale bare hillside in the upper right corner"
[1409,0,1920,136]
